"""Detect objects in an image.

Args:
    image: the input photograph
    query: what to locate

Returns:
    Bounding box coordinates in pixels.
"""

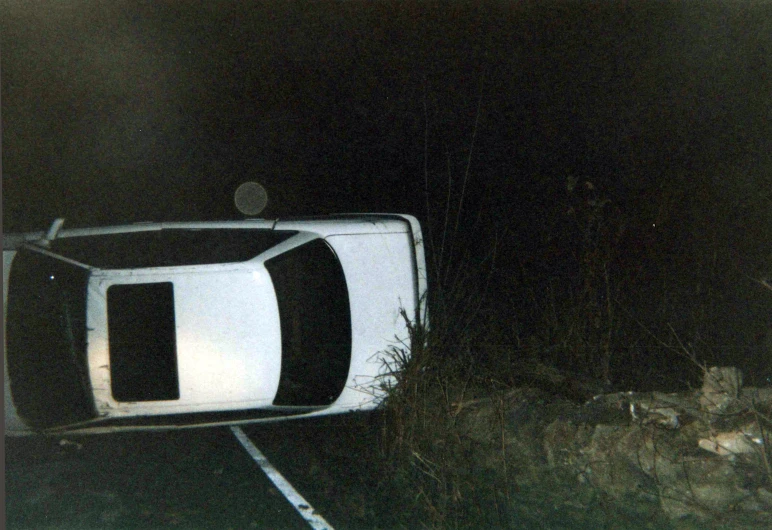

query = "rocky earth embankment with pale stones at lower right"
[456,368,772,528]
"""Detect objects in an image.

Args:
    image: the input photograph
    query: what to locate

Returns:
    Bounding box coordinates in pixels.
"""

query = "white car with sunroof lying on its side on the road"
[3,214,427,435]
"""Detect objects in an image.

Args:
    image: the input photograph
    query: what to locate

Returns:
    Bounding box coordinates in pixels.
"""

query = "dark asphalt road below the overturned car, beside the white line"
[6,422,345,530]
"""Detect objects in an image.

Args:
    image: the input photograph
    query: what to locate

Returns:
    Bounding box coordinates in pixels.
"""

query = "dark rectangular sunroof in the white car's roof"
[107,282,180,401]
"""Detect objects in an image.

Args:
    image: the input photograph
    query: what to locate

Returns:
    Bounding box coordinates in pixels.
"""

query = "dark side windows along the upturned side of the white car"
[50,228,297,269]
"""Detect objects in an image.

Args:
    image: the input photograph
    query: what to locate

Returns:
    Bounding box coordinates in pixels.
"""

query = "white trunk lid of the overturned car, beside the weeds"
[326,232,418,407]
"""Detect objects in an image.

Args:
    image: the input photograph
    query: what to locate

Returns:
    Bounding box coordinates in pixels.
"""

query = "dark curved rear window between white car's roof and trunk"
[265,239,351,406]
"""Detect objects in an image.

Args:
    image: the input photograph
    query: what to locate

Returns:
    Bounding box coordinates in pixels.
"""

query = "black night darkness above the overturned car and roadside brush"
[0,0,772,386]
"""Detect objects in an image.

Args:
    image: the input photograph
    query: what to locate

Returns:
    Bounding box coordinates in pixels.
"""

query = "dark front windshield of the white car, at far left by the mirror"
[6,248,96,428]
